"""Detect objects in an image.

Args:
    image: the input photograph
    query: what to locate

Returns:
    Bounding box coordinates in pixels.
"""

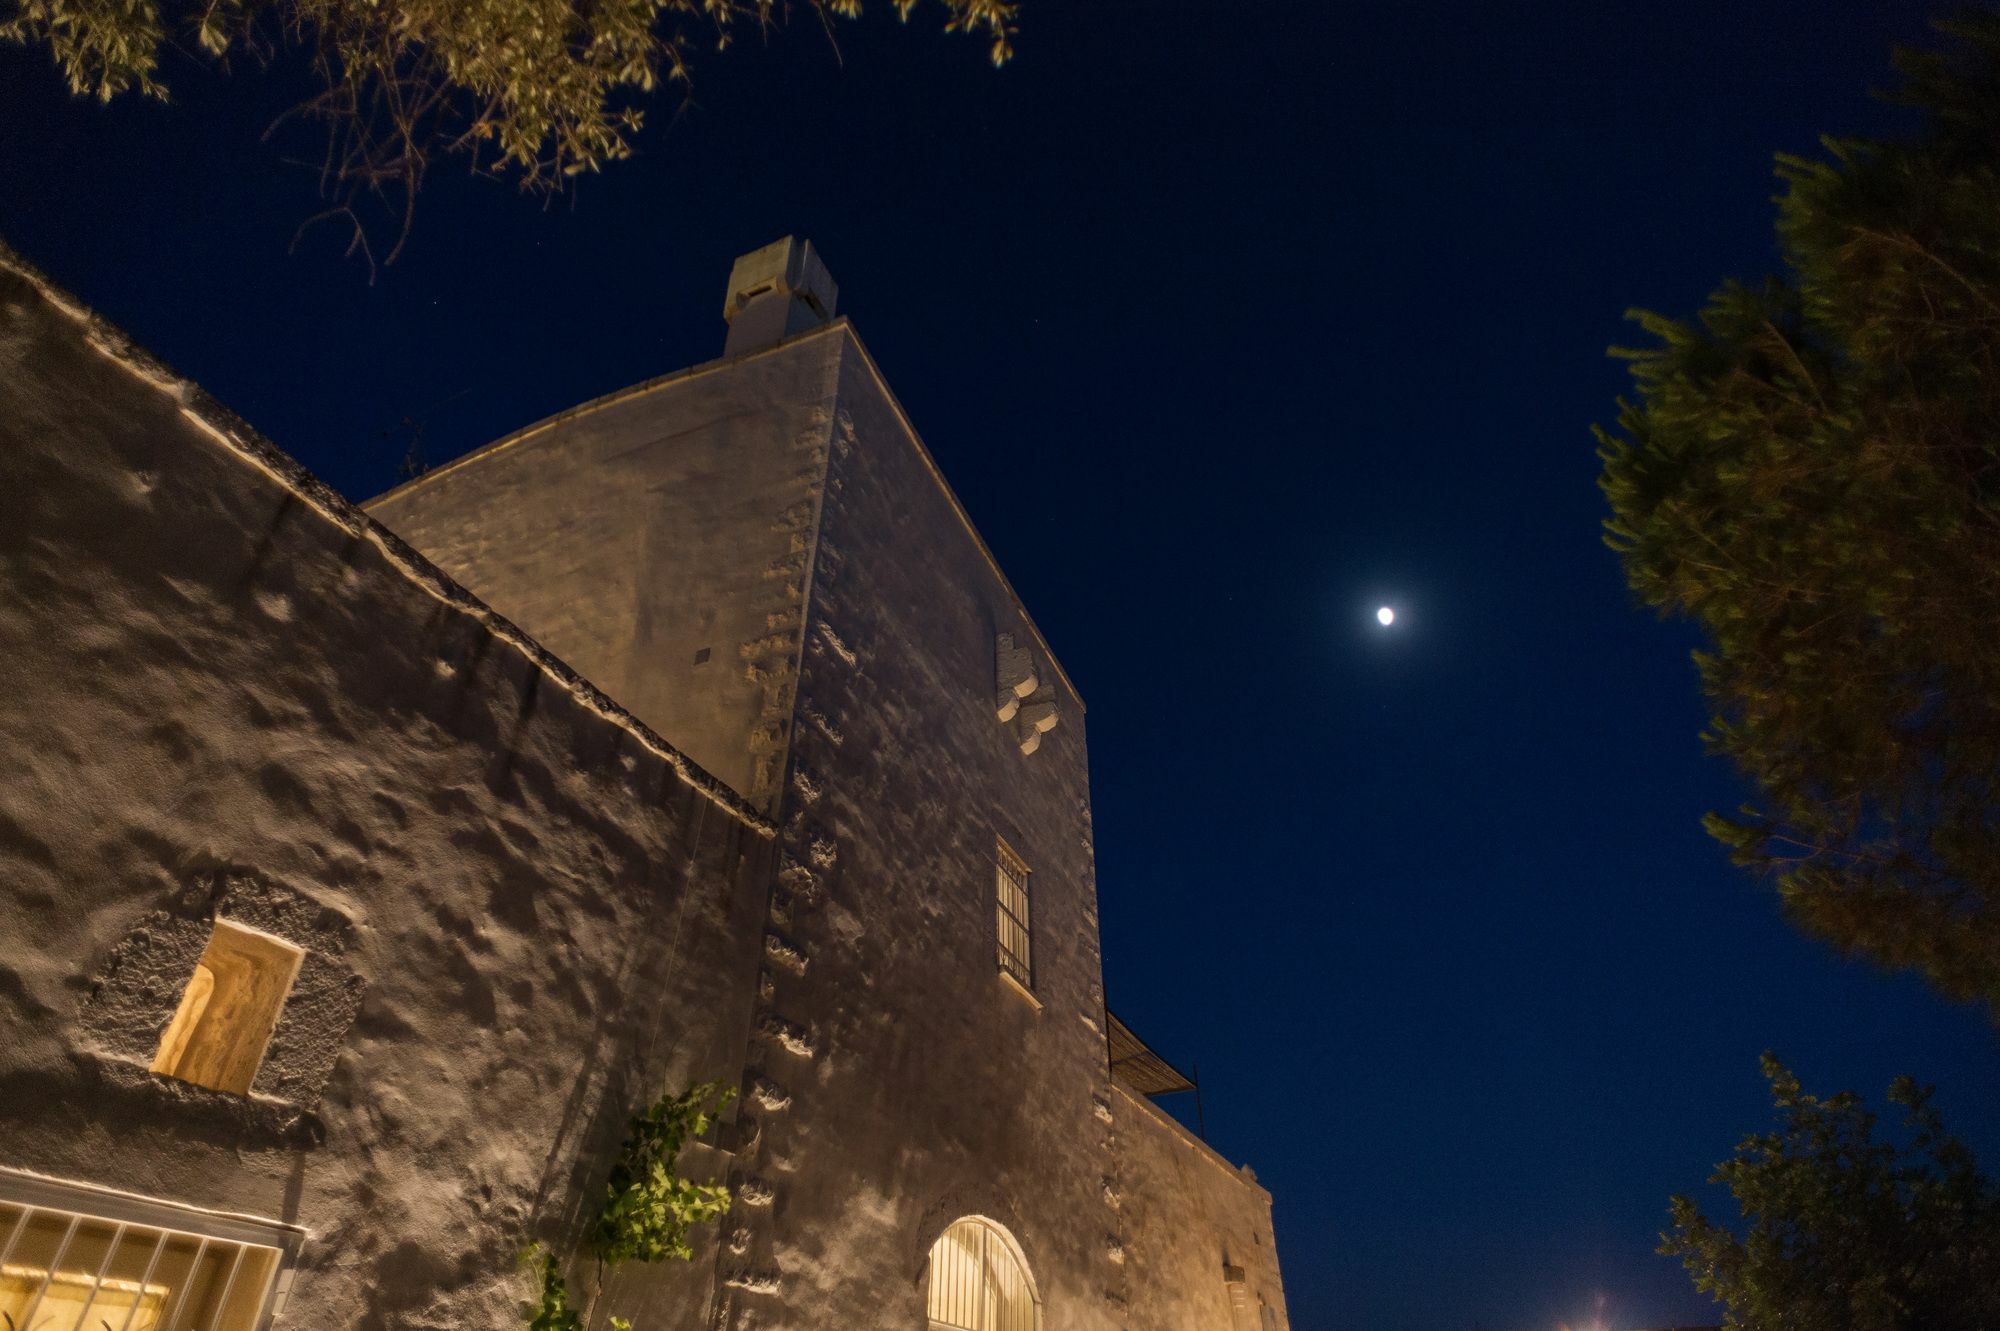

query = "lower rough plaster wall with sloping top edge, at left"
[0,252,774,1329]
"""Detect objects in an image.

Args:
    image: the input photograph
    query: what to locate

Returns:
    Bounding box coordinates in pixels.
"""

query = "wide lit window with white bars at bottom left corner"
[0,1173,300,1331]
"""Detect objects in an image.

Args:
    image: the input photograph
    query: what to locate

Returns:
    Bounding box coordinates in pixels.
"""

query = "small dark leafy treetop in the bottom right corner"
[1660,1053,2000,1331]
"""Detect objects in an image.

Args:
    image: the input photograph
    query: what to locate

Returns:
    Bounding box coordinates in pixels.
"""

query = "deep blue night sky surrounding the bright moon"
[0,0,2000,1331]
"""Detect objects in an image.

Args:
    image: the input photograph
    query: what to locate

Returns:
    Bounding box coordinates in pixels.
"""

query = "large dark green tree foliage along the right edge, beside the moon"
[1598,12,2000,1011]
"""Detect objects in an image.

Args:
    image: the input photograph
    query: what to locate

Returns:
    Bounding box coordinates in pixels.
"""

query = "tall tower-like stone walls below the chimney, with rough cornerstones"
[370,311,1284,1331]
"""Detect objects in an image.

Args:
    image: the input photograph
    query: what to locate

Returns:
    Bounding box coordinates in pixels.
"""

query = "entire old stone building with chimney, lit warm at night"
[0,240,1288,1331]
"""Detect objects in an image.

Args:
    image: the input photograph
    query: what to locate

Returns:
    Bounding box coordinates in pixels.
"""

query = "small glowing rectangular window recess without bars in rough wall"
[152,919,304,1095]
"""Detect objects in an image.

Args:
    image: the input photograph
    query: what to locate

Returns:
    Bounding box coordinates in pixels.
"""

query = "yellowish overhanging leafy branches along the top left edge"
[0,0,1016,262]
